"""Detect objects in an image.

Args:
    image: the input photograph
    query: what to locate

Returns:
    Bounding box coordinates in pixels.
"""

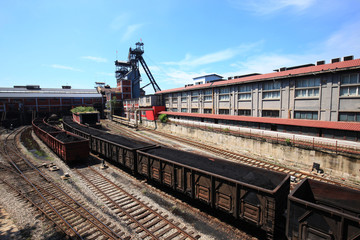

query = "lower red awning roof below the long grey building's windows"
[159,111,360,131]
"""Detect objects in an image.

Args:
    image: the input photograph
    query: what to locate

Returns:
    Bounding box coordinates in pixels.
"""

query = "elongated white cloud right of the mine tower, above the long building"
[163,42,261,67]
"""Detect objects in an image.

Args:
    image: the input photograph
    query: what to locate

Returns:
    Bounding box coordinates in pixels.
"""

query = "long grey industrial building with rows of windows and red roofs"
[156,56,360,141]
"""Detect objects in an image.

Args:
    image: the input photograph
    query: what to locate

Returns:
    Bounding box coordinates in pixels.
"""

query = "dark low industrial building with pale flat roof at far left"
[0,85,105,125]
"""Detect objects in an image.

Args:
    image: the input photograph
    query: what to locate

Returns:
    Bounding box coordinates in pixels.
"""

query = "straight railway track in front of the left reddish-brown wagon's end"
[76,167,200,240]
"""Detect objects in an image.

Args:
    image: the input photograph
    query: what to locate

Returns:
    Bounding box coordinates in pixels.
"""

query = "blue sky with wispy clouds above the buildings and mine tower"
[0,0,360,93]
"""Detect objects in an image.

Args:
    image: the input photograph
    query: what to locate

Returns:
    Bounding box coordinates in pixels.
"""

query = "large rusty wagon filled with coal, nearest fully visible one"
[137,147,290,238]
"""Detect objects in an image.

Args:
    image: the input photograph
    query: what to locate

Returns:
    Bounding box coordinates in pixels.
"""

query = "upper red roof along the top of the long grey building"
[156,59,360,94]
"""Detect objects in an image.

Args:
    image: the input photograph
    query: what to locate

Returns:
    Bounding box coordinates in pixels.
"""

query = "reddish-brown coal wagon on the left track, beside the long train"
[32,119,89,163]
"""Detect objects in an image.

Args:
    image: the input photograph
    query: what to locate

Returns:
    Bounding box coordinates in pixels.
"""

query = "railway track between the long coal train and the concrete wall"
[106,121,360,190]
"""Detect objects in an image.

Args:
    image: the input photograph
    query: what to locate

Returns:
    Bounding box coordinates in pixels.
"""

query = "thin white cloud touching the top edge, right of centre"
[228,0,316,15]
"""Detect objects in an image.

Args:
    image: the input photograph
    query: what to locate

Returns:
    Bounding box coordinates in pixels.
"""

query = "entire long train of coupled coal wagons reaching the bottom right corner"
[64,115,360,240]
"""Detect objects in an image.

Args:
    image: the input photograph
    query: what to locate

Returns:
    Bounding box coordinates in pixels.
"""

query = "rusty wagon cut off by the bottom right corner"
[286,179,360,240]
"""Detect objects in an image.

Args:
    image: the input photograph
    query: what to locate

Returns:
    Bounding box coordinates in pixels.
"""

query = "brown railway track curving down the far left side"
[1,128,125,239]
